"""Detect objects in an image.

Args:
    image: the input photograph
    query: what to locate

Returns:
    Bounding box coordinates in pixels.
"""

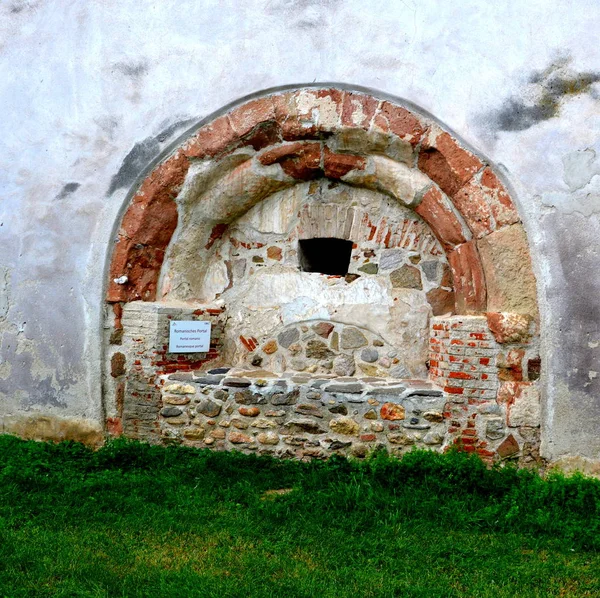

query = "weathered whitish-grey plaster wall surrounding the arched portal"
[0,0,600,468]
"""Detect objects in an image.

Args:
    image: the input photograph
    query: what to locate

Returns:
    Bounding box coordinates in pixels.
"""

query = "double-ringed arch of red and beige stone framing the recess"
[106,87,538,466]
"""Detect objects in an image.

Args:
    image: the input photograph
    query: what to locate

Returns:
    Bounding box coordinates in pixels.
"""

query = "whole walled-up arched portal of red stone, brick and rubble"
[107,88,539,466]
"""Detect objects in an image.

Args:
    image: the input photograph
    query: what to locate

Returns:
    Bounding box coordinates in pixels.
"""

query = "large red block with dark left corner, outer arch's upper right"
[419,133,483,196]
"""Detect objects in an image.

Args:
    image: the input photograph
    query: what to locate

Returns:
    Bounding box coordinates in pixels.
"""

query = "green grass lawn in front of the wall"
[0,436,600,598]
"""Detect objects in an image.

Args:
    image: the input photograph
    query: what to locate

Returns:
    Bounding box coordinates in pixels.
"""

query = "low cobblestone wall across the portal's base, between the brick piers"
[159,368,445,459]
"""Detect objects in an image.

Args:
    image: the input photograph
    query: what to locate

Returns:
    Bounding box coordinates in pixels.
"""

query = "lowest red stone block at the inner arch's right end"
[448,241,486,313]
